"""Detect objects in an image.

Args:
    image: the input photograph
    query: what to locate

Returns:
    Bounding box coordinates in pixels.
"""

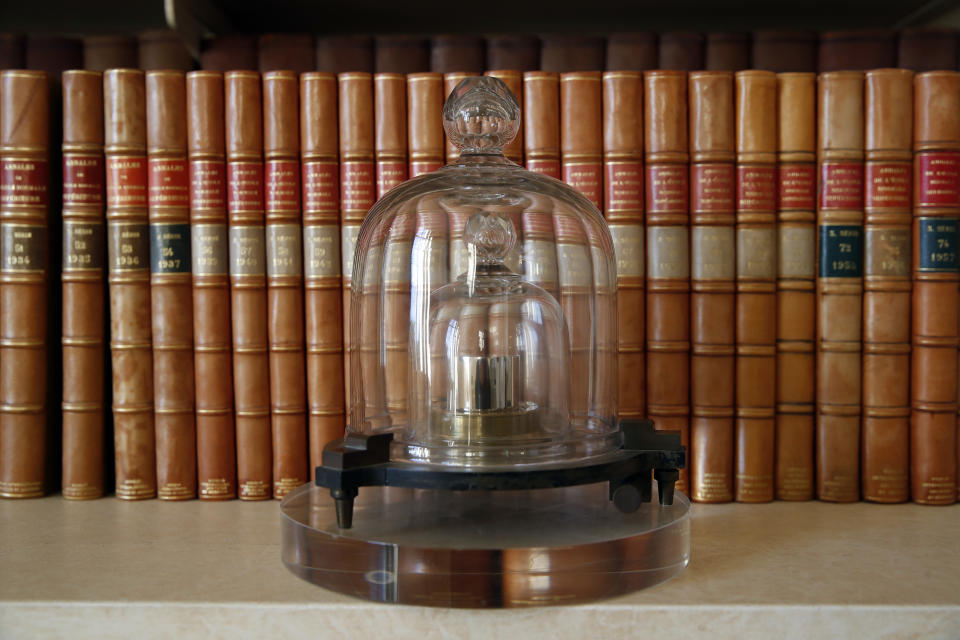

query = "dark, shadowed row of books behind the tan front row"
[0,27,960,73]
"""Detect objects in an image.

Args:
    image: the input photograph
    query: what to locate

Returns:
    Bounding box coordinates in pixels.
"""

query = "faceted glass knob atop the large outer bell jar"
[443,76,520,154]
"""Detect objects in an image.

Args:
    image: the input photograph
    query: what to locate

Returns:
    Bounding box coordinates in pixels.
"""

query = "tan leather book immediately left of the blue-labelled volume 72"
[774,73,817,500]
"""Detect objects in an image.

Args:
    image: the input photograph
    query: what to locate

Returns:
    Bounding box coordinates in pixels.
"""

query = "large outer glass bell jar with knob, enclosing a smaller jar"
[348,77,621,468]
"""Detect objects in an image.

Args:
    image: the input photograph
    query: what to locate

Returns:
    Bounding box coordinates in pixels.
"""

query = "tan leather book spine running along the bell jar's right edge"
[603,71,646,420]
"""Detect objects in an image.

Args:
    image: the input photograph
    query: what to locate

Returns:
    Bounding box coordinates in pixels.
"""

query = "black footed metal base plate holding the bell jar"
[315,420,686,529]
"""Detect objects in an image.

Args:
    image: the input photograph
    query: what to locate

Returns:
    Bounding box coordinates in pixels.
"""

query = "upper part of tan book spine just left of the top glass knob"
[407,72,446,178]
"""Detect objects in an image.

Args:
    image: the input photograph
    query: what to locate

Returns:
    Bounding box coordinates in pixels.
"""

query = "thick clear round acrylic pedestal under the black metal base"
[281,483,690,607]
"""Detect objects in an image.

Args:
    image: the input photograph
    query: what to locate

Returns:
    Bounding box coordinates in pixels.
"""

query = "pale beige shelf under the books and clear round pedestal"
[0,496,960,640]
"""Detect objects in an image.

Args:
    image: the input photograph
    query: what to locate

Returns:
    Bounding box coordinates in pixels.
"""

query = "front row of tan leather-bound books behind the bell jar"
[0,63,960,504]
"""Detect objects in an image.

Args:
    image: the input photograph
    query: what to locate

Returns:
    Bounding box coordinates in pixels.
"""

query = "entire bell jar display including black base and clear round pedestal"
[281,77,689,607]
